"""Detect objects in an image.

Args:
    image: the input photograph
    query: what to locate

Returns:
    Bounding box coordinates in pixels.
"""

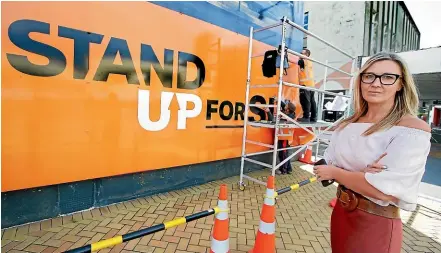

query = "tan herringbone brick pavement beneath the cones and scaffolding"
[1,164,441,253]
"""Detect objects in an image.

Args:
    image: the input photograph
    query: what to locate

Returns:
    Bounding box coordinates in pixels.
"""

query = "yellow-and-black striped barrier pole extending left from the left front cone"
[65,207,222,253]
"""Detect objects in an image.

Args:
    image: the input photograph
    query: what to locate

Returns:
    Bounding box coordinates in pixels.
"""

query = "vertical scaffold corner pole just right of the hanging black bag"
[271,16,286,176]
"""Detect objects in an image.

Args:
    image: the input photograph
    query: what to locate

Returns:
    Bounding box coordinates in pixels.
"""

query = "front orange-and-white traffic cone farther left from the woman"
[210,184,230,253]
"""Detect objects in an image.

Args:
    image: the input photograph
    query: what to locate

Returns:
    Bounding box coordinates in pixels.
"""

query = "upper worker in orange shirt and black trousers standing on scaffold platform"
[297,48,317,122]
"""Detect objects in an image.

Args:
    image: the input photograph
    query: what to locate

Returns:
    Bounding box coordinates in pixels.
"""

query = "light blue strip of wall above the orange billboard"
[156,1,304,52]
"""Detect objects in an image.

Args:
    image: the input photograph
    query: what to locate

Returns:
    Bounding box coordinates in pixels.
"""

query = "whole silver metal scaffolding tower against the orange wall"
[239,17,357,190]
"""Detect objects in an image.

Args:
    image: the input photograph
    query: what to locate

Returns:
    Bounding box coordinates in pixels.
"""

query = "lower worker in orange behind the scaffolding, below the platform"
[264,98,296,174]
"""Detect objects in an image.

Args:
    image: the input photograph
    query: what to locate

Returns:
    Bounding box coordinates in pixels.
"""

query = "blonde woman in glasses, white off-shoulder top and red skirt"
[314,53,431,253]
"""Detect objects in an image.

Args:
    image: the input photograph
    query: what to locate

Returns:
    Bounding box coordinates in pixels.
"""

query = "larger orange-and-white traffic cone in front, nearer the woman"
[249,176,276,253]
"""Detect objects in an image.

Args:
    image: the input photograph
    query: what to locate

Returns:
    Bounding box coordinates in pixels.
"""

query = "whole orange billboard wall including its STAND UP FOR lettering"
[1,2,300,192]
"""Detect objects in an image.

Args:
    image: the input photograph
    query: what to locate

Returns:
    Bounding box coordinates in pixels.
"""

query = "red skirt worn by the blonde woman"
[331,201,403,253]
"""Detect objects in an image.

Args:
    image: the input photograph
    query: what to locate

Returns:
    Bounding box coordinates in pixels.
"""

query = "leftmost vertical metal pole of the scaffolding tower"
[239,27,253,185]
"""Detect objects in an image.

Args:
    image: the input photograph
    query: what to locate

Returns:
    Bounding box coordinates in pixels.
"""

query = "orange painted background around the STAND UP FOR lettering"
[1,2,301,192]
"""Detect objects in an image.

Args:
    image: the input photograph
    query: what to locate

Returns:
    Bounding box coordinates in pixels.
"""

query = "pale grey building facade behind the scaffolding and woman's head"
[304,1,421,90]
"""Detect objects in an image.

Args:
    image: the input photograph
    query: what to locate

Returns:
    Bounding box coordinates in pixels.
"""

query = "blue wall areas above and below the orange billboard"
[1,2,303,228]
